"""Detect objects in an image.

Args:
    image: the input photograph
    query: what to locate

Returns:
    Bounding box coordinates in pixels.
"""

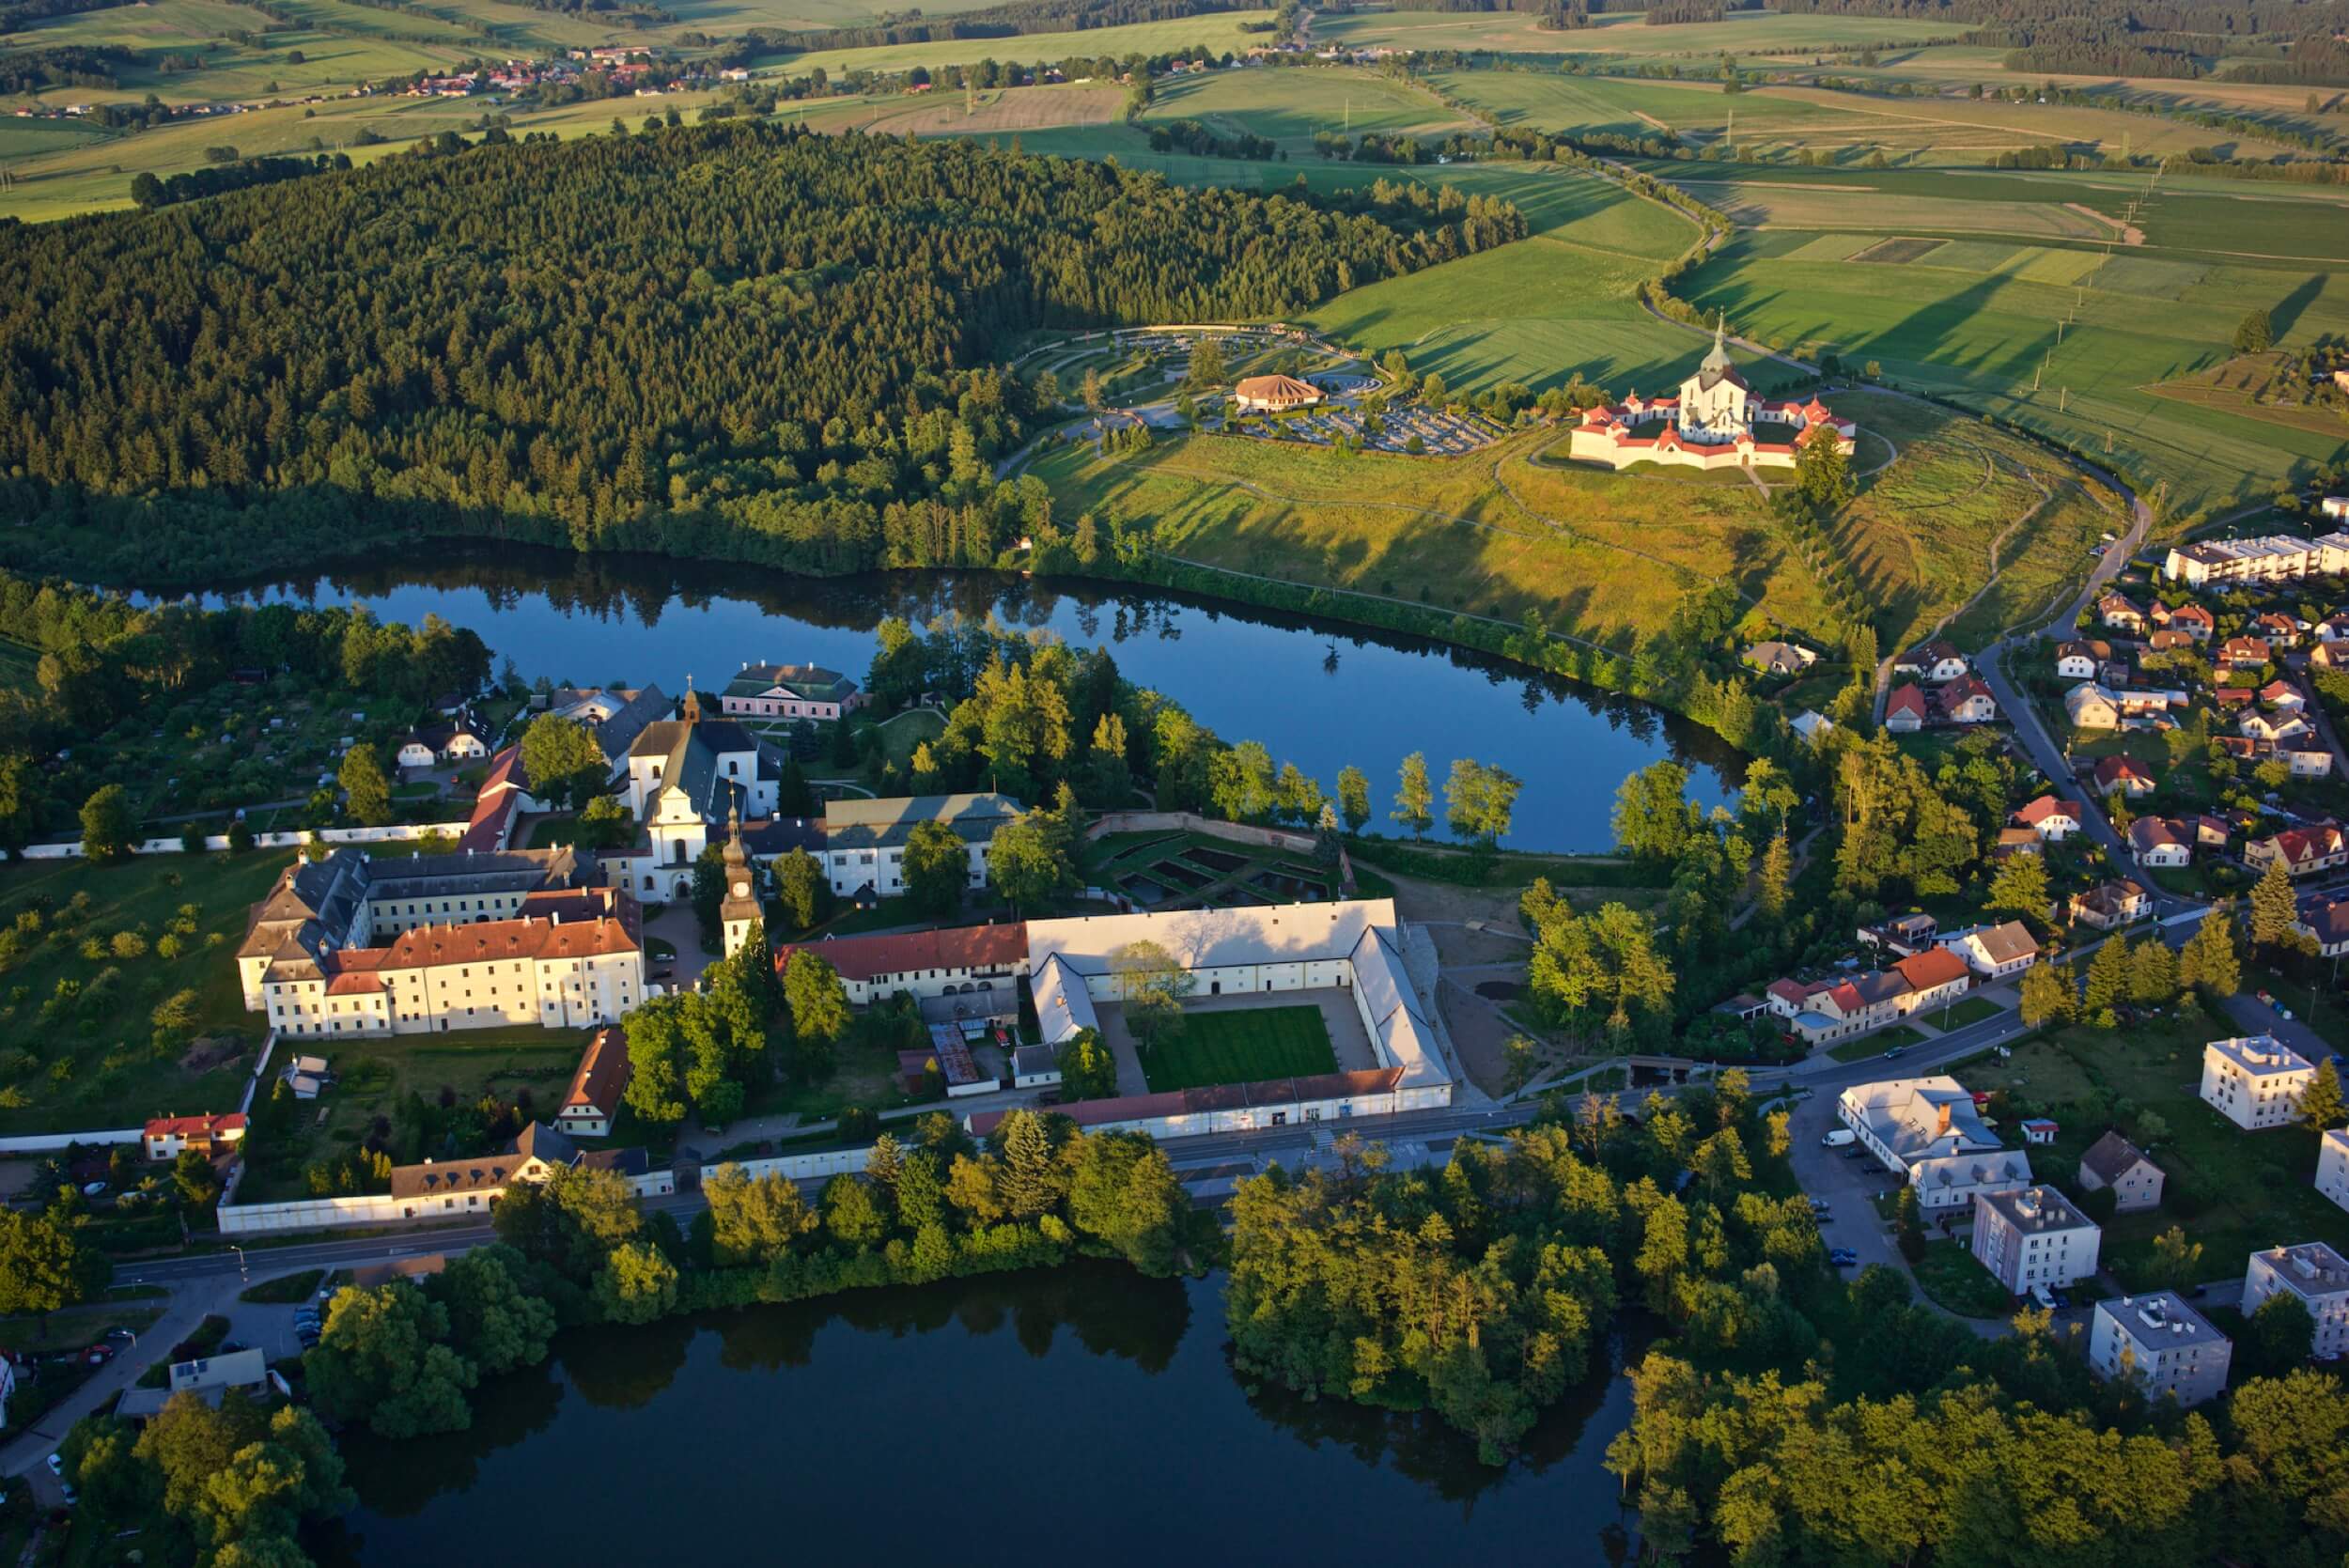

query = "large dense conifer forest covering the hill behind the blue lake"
[0,117,1525,582]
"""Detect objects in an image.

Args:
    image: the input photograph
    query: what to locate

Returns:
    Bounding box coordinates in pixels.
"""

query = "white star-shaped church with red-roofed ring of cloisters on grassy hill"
[1567,321,1859,470]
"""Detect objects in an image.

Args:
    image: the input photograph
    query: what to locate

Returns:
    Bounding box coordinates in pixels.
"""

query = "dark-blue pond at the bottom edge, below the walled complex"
[319,1263,1630,1568]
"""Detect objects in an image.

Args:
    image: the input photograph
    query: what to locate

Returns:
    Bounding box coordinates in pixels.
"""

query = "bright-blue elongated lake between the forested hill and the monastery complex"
[188,547,1743,852]
